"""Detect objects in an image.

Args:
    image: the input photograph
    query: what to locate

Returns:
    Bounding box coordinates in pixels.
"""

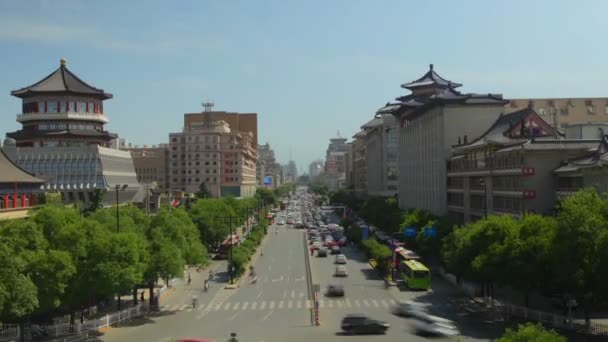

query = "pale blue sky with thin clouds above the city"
[0,0,608,171]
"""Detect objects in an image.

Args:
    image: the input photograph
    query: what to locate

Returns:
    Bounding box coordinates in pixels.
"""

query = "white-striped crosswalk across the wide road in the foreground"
[165,298,397,313]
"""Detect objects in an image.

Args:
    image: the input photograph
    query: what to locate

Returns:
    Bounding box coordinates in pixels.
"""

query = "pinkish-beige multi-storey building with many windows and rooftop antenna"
[169,114,258,197]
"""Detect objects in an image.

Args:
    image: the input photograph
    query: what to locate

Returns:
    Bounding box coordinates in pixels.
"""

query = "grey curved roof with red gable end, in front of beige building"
[454,107,561,150]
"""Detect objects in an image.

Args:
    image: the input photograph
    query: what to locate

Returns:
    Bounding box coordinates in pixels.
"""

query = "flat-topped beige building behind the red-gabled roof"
[505,97,608,128]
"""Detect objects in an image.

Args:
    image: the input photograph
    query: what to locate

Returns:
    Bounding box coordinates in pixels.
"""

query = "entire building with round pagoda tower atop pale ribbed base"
[4,59,141,205]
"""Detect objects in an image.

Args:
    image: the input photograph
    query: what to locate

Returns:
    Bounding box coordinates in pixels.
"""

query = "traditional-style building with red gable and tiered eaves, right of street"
[447,108,606,223]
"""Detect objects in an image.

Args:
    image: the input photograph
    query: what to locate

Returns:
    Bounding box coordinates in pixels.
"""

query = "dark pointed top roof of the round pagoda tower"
[11,59,112,100]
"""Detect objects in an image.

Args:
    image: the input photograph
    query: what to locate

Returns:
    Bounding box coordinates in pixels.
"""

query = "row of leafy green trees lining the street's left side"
[0,205,207,322]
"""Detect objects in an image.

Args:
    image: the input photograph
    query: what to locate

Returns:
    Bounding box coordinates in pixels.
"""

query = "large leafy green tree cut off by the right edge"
[552,189,608,323]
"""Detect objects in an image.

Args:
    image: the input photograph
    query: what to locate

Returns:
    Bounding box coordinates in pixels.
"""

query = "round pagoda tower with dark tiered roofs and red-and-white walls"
[6,59,117,147]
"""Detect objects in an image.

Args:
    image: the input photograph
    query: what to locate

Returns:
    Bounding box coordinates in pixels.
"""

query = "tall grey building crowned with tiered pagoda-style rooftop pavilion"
[378,65,505,216]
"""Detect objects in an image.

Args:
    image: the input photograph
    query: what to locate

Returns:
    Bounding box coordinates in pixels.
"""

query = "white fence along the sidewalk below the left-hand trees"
[0,304,147,342]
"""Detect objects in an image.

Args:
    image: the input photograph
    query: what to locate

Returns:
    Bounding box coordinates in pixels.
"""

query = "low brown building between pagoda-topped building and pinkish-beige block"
[127,144,170,193]
